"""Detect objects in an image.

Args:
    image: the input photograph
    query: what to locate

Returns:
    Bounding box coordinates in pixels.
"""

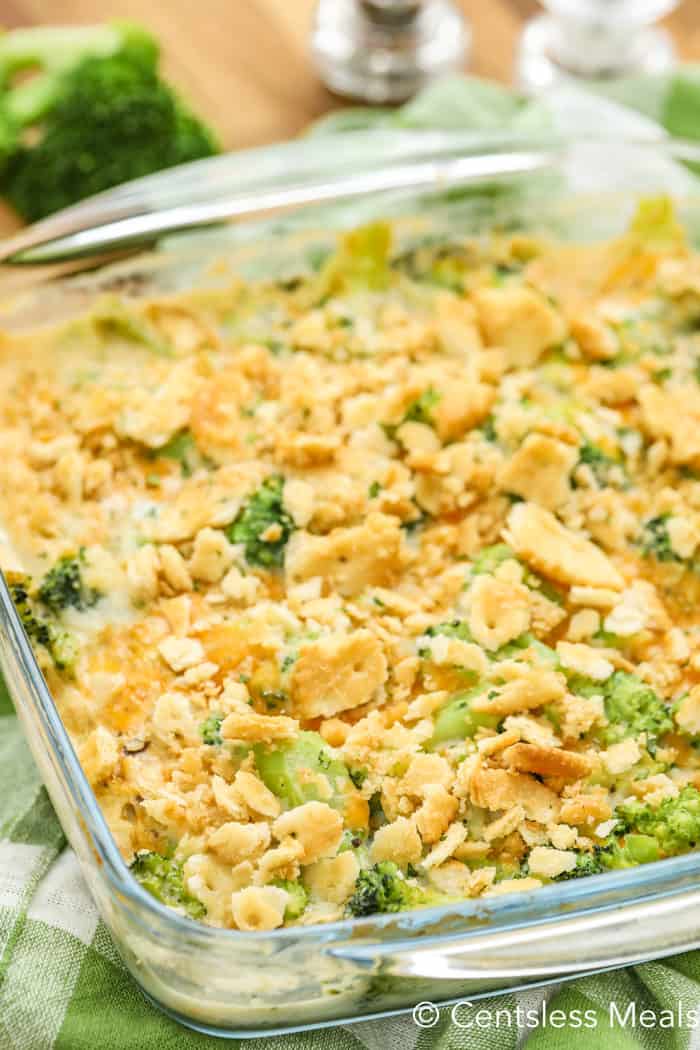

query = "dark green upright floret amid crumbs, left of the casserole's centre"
[227,475,295,569]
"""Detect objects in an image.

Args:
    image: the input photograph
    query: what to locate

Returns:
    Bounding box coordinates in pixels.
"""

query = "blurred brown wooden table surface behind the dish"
[0,0,700,149]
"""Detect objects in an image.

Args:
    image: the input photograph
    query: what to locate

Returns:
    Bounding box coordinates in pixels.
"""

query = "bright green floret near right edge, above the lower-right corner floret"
[598,671,673,754]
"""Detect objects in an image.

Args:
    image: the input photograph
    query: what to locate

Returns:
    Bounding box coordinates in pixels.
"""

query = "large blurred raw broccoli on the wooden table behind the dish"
[0,23,218,222]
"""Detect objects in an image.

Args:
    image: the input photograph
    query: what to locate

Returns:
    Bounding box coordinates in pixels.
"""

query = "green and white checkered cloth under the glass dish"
[6,69,700,1050]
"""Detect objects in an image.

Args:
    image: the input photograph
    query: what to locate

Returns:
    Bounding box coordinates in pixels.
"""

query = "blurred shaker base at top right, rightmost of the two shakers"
[516,0,679,92]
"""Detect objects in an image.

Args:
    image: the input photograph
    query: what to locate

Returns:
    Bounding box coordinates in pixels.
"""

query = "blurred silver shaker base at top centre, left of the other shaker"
[312,0,470,103]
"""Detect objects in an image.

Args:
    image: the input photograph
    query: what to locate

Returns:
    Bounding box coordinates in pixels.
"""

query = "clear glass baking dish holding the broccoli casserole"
[0,132,700,1037]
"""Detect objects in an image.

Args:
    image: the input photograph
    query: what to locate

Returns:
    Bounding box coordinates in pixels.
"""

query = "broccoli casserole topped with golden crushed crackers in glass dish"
[6,200,700,930]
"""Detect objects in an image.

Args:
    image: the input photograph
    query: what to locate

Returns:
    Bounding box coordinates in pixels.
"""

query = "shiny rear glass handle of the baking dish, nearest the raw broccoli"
[0,148,556,265]
